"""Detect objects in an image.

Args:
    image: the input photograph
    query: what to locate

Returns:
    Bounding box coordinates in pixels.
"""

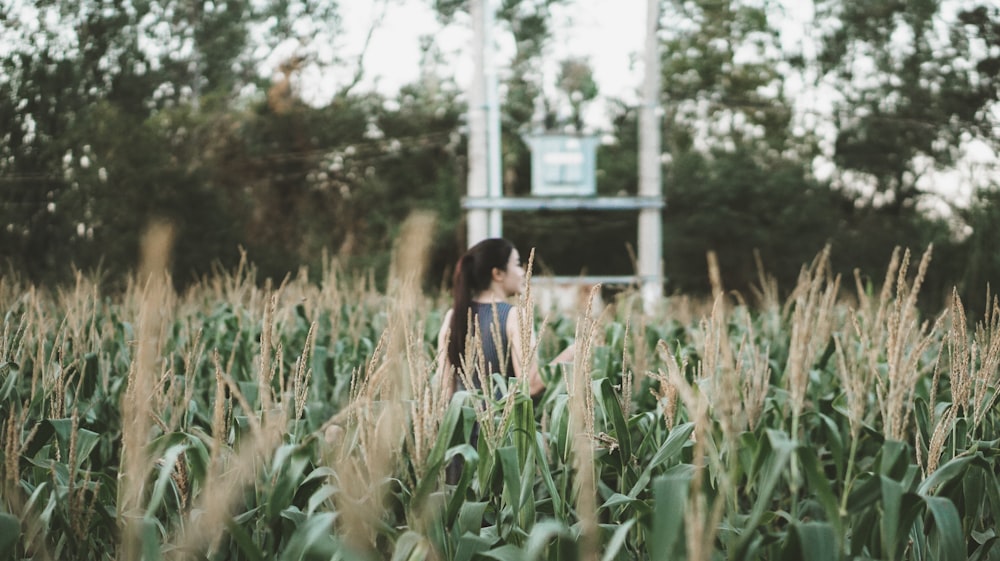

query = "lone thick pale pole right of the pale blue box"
[639,0,663,313]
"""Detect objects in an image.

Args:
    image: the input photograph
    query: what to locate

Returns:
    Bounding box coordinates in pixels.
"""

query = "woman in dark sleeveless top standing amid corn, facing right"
[438,238,545,397]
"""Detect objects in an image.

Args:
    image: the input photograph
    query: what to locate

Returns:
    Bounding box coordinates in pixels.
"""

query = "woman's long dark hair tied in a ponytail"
[448,238,514,372]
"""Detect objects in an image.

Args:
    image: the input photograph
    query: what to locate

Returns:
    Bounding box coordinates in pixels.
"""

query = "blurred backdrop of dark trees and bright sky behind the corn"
[0,0,1000,310]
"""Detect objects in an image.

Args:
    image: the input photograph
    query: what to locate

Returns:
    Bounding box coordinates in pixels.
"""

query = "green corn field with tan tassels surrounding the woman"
[0,226,1000,561]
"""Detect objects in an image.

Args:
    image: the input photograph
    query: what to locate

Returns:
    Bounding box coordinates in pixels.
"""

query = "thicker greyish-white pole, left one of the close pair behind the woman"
[466,0,489,247]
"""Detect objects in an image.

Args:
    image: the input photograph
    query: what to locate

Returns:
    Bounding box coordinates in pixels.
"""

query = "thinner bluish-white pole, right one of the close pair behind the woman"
[483,0,503,238]
